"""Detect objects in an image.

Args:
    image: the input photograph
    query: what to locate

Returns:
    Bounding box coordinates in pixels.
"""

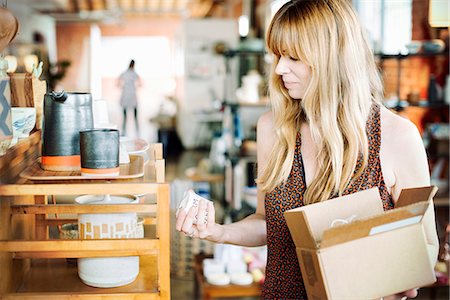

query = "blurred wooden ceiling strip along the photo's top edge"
[9,0,232,22]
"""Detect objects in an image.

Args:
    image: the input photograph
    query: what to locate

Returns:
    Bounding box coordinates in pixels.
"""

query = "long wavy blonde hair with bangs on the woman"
[257,0,383,204]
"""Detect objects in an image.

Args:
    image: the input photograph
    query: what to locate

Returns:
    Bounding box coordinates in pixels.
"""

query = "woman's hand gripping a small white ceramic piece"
[176,199,223,242]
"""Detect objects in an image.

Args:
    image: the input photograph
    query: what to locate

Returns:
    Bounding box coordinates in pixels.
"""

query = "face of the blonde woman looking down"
[275,55,311,100]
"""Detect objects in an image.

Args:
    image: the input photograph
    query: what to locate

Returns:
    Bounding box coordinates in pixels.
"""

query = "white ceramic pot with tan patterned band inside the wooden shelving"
[75,195,139,288]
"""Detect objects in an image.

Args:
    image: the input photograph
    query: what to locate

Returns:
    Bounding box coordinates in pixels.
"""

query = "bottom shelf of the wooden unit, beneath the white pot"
[2,256,158,299]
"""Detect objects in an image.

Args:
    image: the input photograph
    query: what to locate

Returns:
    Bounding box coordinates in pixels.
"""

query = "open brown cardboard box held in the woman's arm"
[284,187,437,299]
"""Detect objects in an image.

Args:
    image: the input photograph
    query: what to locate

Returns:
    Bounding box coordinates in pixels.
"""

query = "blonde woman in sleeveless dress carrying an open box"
[176,0,438,300]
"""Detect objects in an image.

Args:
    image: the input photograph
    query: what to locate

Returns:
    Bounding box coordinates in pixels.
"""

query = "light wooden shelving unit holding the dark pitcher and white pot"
[0,132,170,299]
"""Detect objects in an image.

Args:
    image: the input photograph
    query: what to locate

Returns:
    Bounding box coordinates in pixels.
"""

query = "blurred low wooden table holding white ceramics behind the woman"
[194,254,261,299]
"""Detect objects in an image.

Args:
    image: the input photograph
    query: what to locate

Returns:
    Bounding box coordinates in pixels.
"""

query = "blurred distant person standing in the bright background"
[117,59,141,135]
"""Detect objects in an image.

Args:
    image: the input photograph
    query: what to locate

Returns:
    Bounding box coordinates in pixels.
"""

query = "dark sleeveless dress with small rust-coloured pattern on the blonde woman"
[262,105,394,299]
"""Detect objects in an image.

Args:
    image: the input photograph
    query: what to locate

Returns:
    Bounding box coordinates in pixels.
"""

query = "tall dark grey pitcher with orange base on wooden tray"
[41,91,94,171]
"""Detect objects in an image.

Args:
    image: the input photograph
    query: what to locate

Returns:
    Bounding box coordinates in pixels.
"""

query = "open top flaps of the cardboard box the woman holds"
[284,186,437,249]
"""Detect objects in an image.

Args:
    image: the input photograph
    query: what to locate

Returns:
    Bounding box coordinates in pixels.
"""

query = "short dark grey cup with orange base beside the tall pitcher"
[80,129,119,176]
